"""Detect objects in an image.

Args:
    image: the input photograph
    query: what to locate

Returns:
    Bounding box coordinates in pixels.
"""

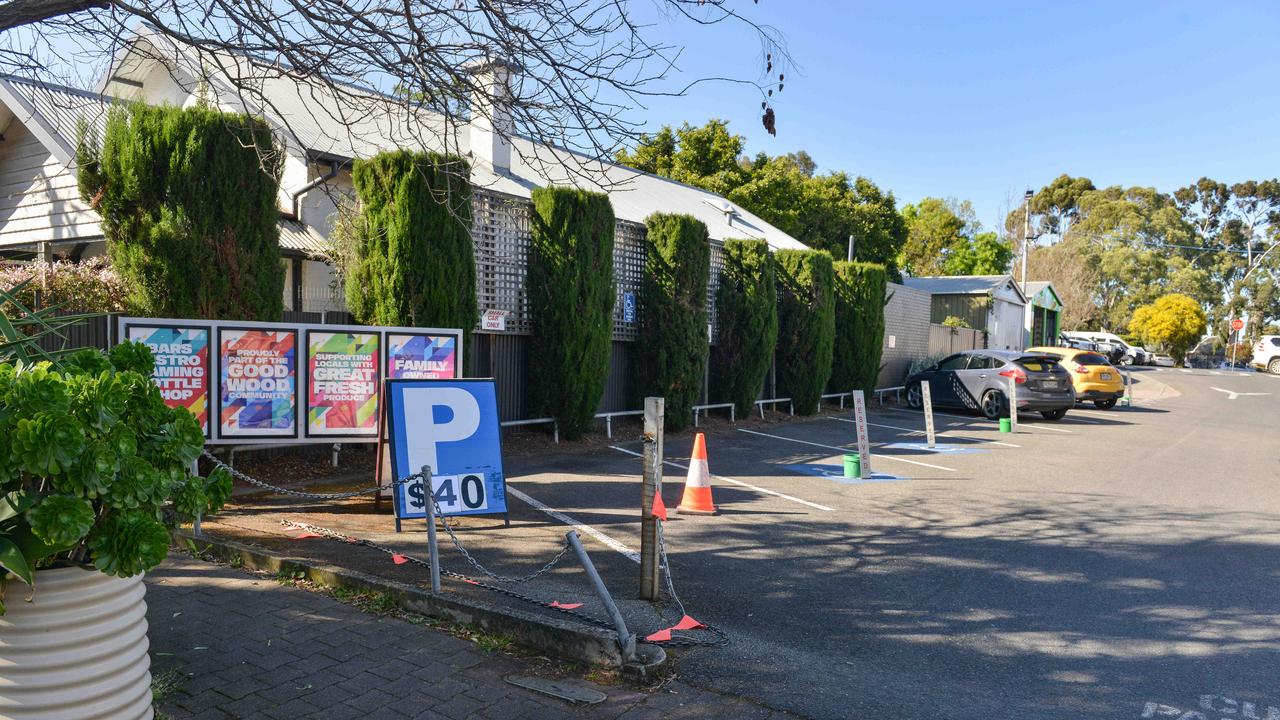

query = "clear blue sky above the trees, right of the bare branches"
[640,0,1280,228]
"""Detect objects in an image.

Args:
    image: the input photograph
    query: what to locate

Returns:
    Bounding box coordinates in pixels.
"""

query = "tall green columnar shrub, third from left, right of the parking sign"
[526,187,614,438]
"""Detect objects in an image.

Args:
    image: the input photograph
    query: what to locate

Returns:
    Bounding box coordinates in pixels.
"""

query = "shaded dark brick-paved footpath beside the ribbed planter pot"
[147,553,791,720]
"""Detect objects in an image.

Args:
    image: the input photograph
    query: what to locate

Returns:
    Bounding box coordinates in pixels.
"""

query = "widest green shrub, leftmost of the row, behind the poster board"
[78,104,284,320]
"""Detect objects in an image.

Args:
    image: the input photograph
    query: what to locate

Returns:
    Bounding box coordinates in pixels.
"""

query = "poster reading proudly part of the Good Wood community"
[218,328,298,437]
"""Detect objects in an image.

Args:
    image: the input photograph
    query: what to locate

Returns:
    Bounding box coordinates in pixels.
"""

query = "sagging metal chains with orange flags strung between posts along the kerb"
[202,450,728,647]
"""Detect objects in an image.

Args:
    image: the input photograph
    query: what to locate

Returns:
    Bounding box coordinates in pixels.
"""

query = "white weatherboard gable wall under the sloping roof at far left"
[0,120,102,247]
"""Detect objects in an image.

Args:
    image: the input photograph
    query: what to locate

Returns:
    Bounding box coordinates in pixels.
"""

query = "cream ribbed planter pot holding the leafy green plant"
[0,568,152,720]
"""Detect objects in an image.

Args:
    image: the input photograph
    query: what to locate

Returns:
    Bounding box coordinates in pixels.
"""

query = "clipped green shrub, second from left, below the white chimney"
[343,150,479,336]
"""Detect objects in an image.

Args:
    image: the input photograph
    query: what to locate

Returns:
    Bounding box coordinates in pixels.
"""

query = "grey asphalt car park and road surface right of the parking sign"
[507,369,1280,720]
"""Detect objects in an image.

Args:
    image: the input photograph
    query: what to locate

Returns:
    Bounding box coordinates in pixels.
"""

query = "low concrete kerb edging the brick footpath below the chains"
[170,530,668,679]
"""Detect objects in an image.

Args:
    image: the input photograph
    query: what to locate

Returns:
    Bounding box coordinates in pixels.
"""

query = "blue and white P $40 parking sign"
[387,379,507,519]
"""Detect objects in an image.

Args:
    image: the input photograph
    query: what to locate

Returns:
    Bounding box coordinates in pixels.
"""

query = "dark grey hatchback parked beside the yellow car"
[906,350,1075,420]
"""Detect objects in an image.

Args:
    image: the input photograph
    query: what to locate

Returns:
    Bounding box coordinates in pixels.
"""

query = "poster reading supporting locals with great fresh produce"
[307,331,378,436]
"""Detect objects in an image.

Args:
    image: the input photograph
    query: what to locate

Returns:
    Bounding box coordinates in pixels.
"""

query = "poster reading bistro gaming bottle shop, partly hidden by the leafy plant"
[128,325,209,437]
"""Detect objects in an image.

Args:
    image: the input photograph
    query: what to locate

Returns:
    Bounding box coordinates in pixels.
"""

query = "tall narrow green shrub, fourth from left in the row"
[636,213,710,430]
